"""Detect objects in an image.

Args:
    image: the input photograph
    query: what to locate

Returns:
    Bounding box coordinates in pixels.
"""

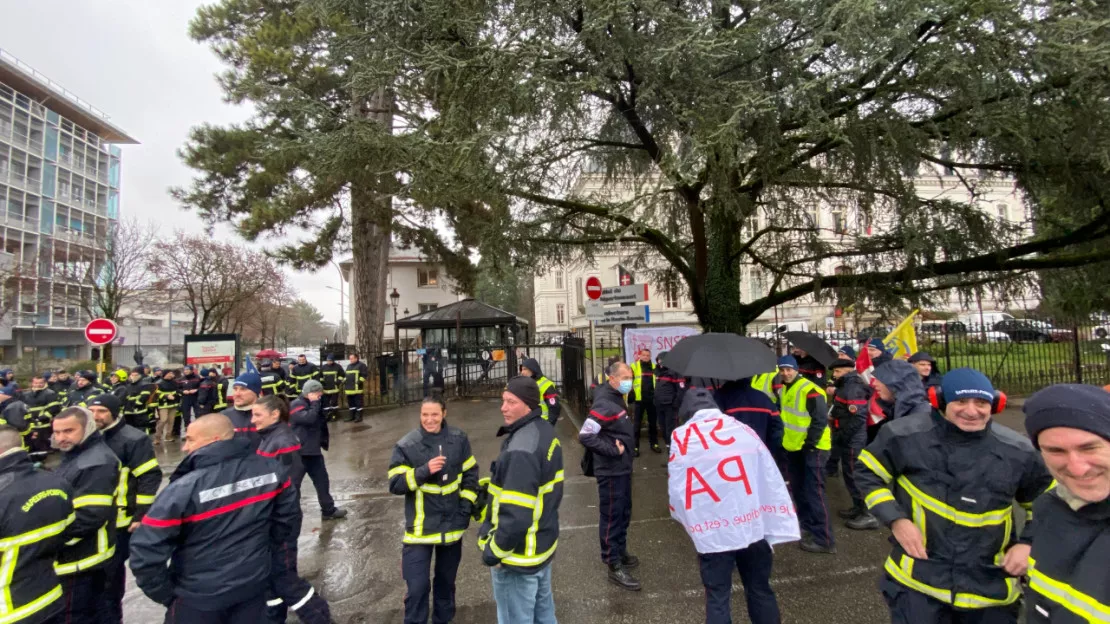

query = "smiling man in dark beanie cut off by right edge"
[1025,384,1110,624]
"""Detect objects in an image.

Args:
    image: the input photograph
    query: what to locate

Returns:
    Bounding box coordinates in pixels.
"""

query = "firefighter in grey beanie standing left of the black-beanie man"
[51,406,120,622]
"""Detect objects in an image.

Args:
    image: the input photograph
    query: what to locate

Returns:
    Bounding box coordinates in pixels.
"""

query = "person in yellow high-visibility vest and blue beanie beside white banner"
[778,355,836,554]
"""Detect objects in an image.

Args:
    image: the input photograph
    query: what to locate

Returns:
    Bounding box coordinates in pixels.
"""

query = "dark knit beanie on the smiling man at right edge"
[1022,383,1110,449]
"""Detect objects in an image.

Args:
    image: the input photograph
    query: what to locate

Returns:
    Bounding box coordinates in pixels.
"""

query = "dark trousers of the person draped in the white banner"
[697,540,781,624]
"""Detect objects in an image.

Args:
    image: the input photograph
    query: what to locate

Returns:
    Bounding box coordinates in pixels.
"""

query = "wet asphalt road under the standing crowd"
[124,400,1021,624]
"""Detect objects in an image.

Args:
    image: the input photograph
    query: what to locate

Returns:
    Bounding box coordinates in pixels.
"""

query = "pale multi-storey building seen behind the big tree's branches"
[535,163,1037,335]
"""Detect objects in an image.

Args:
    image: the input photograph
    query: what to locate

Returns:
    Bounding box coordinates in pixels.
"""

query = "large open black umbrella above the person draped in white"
[663,333,778,381]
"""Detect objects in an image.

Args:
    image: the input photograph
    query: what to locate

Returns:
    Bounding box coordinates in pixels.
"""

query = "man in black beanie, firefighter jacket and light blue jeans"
[478,376,564,623]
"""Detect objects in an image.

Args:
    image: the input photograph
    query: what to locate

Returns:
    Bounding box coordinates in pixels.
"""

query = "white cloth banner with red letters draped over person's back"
[667,410,801,553]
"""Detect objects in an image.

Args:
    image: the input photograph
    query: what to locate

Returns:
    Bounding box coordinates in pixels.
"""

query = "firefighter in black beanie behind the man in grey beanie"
[89,393,162,622]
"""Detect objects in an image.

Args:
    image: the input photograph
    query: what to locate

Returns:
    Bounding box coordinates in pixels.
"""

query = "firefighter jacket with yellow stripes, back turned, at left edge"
[0,449,73,624]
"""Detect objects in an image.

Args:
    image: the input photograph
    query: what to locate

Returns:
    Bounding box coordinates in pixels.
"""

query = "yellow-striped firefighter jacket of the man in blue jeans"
[478,407,563,573]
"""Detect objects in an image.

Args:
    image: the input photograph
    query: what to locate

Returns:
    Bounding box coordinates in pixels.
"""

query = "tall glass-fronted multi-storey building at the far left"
[0,50,137,362]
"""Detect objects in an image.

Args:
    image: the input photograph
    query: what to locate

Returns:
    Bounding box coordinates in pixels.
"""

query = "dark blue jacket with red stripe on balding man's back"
[131,437,301,611]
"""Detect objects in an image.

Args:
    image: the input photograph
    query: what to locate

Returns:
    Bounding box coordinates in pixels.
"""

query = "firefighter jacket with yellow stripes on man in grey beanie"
[54,431,120,575]
